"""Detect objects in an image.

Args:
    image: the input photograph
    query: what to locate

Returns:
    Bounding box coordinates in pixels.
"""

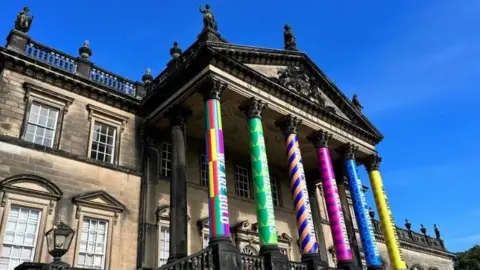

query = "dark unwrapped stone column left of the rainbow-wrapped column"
[168,107,191,262]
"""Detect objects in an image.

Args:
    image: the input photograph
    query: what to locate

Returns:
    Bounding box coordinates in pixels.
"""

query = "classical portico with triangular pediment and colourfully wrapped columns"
[137,4,403,269]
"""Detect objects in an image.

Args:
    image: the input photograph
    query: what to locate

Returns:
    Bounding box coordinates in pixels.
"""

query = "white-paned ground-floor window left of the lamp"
[0,206,40,270]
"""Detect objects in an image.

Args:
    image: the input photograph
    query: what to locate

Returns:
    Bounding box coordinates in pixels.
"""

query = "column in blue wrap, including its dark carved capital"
[339,144,383,270]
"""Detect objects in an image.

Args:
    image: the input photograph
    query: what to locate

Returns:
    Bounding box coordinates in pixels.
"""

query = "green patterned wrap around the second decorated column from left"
[248,118,278,246]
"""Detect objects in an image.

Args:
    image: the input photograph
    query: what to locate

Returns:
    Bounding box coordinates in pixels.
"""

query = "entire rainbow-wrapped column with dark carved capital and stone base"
[202,78,242,270]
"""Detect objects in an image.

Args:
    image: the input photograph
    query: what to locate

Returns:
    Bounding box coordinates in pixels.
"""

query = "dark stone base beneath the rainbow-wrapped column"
[208,236,242,270]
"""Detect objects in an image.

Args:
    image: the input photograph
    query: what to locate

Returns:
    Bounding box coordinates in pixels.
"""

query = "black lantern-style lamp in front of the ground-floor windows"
[44,221,75,270]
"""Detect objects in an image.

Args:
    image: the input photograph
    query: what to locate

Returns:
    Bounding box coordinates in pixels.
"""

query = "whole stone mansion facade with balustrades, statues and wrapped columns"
[0,5,454,270]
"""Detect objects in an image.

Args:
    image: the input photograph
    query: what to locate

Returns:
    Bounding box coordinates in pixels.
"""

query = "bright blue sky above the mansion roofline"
[0,0,480,251]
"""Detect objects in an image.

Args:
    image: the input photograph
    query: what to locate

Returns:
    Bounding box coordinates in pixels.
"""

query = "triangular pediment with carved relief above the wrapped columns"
[211,43,383,143]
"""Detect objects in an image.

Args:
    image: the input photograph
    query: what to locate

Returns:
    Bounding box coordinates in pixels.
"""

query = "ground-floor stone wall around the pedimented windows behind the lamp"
[0,142,141,270]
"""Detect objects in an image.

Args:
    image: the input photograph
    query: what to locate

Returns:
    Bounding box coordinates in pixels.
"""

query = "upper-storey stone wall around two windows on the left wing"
[0,70,142,169]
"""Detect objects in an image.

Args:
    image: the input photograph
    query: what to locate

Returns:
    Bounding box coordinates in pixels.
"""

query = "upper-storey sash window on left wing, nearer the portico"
[90,123,117,163]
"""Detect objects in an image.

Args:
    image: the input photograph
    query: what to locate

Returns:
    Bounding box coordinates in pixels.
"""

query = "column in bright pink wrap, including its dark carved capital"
[308,131,358,269]
